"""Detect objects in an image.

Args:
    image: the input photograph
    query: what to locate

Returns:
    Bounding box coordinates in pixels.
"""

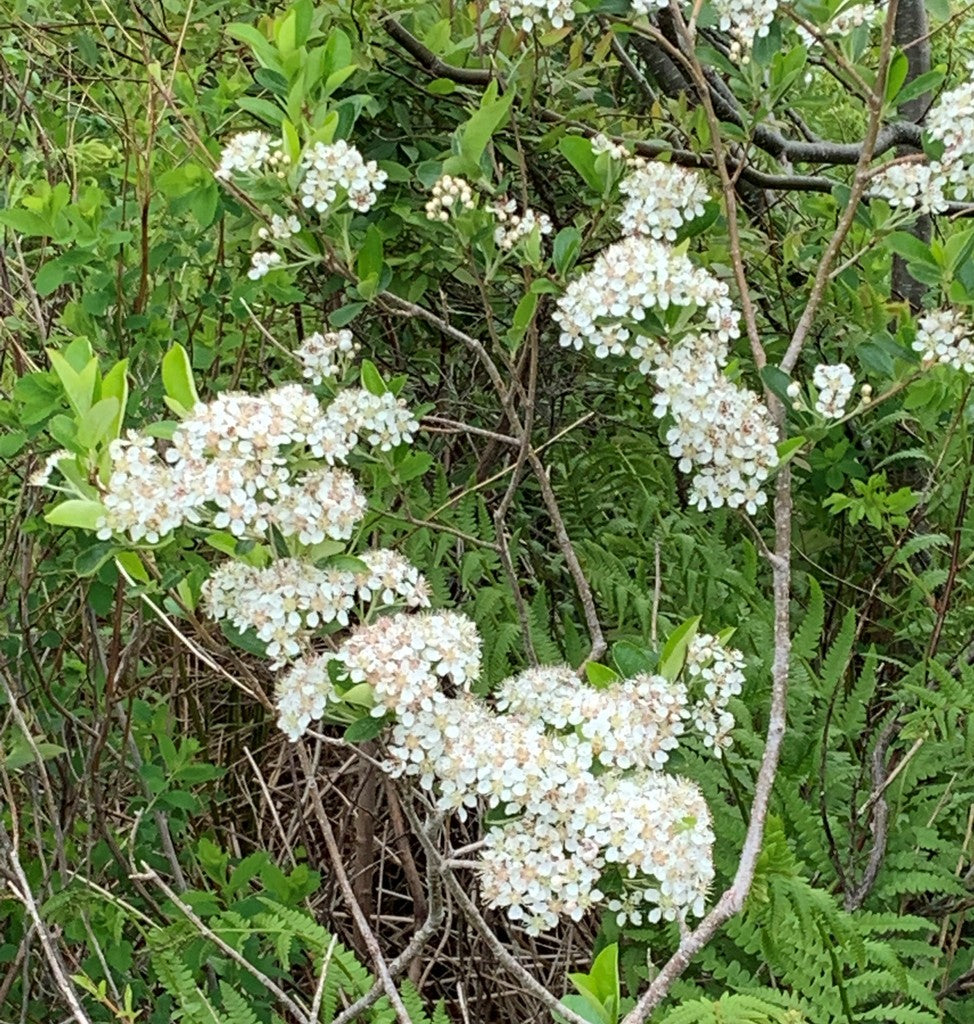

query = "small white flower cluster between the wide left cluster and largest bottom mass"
[203,548,429,667]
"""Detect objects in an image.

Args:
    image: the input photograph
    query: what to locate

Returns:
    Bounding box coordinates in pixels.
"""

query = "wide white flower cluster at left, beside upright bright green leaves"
[92,384,419,544]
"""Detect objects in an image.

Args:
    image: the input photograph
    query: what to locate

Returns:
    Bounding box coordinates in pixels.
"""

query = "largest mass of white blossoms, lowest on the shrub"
[354,613,744,934]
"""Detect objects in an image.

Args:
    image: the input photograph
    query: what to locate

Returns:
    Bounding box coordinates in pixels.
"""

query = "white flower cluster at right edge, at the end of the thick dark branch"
[872,65,974,213]
